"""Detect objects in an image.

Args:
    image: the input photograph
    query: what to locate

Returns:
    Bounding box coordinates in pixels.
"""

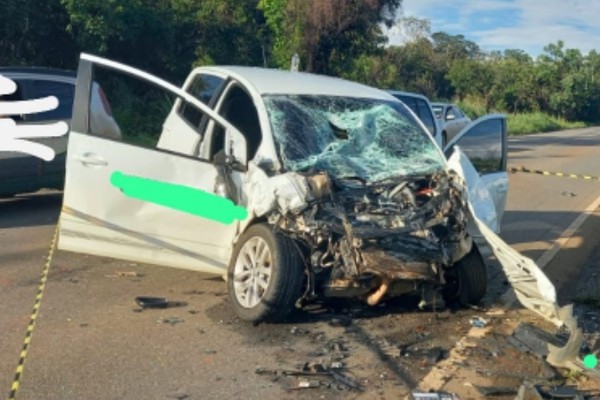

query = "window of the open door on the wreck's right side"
[455,118,506,174]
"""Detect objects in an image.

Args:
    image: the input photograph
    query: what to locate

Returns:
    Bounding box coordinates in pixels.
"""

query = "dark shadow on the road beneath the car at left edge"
[0,192,62,229]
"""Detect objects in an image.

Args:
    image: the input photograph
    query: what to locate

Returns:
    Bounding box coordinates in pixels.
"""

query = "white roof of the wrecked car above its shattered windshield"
[194,66,396,100]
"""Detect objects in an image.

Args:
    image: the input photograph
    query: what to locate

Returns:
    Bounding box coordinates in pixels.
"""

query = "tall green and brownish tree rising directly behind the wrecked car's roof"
[259,0,401,76]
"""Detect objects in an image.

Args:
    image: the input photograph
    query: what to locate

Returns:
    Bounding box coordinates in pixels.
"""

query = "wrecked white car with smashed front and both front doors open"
[59,54,524,321]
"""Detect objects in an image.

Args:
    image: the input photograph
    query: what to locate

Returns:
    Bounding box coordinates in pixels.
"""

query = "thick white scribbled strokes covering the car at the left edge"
[0,75,69,161]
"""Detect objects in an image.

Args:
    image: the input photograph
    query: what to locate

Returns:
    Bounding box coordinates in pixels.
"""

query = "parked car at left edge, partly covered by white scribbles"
[0,67,121,197]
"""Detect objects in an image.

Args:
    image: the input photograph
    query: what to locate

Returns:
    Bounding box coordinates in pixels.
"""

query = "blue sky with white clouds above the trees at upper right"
[388,0,600,57]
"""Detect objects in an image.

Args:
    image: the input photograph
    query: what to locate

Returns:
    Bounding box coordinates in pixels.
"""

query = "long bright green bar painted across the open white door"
[110,171,248,225]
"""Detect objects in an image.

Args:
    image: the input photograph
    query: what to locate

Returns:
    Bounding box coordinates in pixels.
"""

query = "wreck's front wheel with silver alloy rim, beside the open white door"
[227,224,305,322]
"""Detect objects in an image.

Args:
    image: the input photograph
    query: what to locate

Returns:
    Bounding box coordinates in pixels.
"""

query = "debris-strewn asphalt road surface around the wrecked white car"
[0,128,600,399]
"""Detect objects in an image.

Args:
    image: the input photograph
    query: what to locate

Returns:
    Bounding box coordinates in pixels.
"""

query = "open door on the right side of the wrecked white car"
[444,114,508,233]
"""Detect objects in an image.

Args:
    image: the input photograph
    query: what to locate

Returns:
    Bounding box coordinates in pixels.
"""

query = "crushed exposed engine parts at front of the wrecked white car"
[269,172,472,305]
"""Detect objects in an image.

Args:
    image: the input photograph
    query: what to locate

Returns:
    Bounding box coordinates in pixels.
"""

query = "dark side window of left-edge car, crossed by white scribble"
[27,80,75,121]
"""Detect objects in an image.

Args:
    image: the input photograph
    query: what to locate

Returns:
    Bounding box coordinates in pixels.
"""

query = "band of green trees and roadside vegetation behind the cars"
[0,0,600,135]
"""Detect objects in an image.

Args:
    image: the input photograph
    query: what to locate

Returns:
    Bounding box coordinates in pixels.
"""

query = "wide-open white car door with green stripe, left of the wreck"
[58,54,246,274]
